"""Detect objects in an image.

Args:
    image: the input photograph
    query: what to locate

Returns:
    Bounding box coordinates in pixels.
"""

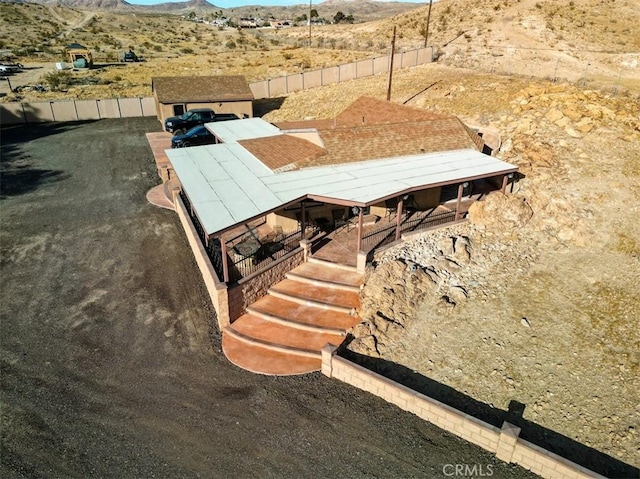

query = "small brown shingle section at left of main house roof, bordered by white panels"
[238,135,327,170]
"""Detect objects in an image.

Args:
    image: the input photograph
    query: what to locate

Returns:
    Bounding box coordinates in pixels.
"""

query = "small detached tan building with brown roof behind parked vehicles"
[151,75,254,124]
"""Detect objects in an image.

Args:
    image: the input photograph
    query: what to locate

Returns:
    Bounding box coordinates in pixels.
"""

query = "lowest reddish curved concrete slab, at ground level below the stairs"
[222,333,322,376]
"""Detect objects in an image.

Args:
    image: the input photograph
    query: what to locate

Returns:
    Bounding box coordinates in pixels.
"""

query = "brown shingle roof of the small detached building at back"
[151,75,253,103]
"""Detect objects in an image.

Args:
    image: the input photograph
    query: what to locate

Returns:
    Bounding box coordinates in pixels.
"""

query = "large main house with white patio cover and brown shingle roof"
[161,97,518,332]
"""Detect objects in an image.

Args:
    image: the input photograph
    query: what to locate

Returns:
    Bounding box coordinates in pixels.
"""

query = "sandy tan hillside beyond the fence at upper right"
[278,0,640,89]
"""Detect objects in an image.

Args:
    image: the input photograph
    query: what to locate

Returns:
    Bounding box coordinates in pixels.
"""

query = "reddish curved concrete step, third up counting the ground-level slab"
[247,295,359,335]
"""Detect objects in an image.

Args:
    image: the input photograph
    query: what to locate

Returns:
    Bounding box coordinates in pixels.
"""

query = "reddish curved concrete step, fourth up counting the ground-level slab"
[269,279,360,314]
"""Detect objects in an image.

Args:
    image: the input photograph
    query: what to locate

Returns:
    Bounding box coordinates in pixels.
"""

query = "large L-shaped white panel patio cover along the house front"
[166,140,518,239]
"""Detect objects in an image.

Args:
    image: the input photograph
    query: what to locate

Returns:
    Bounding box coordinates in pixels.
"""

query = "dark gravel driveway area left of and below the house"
[0,119,532,478]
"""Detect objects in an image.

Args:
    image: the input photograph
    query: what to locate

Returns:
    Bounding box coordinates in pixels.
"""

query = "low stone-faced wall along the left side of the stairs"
[228,248,304,322]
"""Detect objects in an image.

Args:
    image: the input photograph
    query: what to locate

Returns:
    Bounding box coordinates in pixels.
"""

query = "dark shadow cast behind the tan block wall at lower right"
[339,348,640,478]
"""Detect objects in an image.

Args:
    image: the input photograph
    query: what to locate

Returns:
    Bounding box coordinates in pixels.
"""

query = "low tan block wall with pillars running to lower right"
[322,344,604,479]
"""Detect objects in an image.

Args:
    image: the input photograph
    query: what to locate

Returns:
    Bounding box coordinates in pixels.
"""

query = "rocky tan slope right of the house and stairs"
[350,78,640,477]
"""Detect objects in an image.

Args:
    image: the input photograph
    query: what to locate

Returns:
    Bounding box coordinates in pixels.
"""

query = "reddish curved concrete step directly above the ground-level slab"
[225,314,344,356]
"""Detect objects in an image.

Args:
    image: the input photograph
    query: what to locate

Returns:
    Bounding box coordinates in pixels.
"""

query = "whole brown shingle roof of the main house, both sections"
[240,97,483,169]
